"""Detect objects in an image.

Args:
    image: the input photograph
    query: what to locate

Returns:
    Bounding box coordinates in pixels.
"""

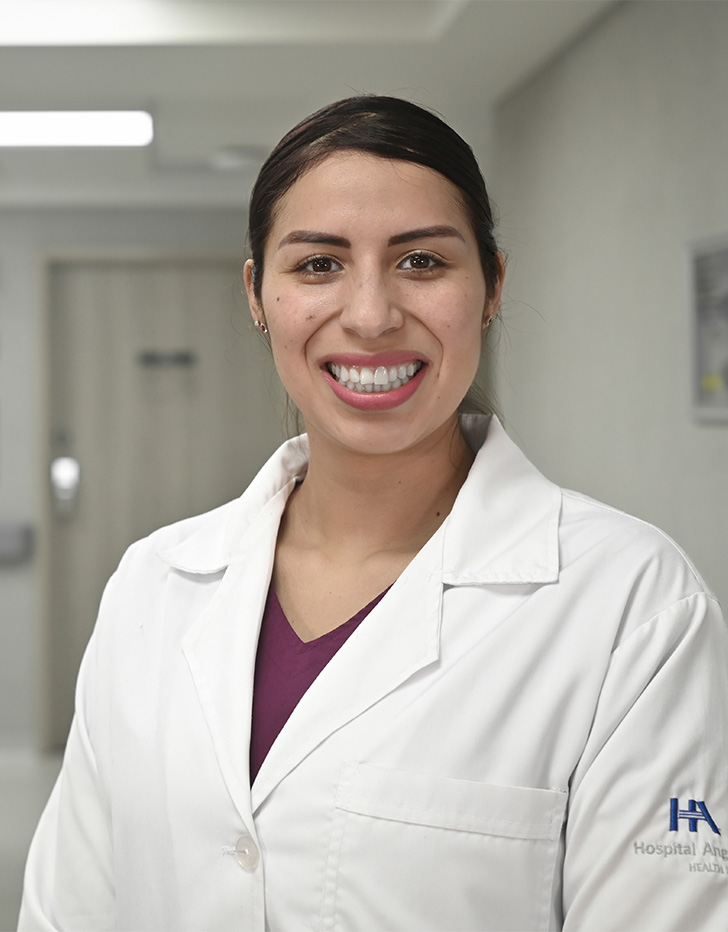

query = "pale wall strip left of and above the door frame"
[0,208,246,746]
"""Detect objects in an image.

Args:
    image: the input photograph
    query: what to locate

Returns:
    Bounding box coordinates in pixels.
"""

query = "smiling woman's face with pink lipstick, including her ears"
[245,150,494,464]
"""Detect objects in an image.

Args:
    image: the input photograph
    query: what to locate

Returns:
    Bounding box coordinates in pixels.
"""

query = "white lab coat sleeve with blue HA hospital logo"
[563,593,728,932]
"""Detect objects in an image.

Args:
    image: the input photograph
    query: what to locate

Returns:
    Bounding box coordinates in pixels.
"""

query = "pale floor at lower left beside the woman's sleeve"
[0,747,60,932]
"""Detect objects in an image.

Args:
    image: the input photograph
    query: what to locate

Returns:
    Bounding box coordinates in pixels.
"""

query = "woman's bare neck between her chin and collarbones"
[285,419,473,560]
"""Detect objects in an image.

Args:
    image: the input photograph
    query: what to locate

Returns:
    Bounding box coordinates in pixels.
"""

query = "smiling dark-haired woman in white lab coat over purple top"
[21,97,728,932]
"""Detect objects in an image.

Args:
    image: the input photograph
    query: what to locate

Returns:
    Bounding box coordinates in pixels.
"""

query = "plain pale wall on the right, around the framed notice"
[496,2,728,606]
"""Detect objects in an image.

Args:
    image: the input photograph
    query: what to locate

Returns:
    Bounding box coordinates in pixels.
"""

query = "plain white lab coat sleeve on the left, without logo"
[18,584,116,932]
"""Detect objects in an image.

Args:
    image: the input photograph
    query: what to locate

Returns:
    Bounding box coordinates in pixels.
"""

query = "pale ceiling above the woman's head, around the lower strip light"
[0,0,614,207]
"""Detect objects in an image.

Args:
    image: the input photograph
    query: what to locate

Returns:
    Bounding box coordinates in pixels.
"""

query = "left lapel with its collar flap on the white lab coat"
[159,437,308,818]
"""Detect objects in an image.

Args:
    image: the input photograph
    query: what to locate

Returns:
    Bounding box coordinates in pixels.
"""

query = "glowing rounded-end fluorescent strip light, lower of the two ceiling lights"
[0,110,154,148]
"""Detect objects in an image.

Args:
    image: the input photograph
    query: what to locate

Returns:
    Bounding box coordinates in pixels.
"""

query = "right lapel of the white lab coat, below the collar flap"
[252,528,443,813]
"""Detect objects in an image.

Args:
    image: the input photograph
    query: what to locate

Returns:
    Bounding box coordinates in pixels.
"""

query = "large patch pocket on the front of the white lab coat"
[322,763,567,932]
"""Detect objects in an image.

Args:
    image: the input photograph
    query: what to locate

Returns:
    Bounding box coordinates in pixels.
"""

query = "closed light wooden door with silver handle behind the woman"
[42,258,282,747]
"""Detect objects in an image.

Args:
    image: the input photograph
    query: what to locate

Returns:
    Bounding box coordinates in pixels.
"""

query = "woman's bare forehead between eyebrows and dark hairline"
[272,150,470,237]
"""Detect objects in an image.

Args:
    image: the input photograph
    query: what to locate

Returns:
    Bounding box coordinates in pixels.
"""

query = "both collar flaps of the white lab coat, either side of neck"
[160,415,561,586]
